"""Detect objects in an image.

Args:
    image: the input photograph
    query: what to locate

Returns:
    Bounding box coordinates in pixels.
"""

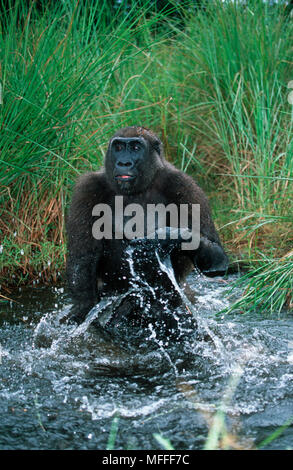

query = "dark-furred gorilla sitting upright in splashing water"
[66,126,228,328]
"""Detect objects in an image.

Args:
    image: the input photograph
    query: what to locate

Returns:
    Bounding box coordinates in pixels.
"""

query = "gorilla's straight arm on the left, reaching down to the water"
[66,173,104,321]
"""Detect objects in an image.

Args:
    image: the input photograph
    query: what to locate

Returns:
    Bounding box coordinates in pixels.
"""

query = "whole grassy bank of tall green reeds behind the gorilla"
[0,0,293,309]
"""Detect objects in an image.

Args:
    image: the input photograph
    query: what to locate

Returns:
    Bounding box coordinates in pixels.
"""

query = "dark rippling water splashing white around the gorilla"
[0,274,293,450]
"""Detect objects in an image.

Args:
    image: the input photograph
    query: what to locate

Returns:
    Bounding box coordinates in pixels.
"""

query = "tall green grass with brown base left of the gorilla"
[0,1,172,284]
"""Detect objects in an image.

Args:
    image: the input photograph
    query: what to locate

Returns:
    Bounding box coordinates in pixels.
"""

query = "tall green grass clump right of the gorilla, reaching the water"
[169,1,293,311]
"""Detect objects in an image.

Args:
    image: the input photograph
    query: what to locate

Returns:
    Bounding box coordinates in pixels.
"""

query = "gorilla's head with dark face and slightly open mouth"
[105,126,164,194]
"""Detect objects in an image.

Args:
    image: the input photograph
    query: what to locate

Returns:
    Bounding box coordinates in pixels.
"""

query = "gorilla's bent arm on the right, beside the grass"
[164,163,229,276]
